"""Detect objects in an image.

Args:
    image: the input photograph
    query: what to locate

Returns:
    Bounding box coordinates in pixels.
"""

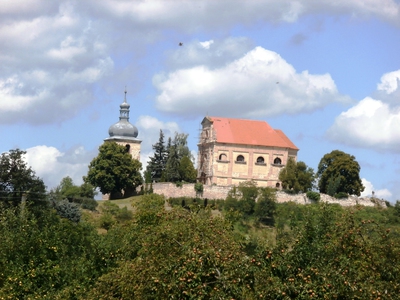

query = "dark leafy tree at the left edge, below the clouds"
[0,149,47,206]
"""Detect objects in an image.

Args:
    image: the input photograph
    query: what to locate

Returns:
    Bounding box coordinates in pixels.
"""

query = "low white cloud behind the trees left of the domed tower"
[25,145,97,189]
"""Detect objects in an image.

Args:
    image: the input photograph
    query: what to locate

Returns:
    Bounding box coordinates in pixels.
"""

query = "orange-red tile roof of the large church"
[206,117,299,150]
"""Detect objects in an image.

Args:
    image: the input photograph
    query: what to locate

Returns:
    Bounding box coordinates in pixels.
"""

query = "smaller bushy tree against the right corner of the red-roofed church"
[279,157,314,193]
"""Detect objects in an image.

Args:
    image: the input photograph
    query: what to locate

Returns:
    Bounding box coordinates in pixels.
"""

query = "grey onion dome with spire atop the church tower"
[108,91,139,140]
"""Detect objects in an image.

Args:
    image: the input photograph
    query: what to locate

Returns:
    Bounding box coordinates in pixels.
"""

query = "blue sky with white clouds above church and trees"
[0,0,400,202]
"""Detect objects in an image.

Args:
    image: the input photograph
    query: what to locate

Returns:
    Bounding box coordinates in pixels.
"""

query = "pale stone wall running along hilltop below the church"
[153,183,386,208]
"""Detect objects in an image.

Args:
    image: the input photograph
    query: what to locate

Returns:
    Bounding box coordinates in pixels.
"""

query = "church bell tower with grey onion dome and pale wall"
[104,91,142,160]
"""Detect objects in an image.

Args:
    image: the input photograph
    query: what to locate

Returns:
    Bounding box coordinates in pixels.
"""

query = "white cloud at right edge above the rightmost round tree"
[327,97,400,152]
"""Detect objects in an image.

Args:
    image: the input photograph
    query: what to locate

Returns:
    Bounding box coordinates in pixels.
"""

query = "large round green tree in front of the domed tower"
[86,142,142,197]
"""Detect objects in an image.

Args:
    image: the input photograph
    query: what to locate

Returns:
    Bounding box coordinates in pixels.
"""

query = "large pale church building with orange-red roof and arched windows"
[198,117,299,187]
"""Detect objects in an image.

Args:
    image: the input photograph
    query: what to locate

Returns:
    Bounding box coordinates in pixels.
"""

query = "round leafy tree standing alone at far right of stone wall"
[317,150,364,196]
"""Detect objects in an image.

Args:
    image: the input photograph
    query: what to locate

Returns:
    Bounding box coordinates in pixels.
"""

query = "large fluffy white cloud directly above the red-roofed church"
[153,47,348,117]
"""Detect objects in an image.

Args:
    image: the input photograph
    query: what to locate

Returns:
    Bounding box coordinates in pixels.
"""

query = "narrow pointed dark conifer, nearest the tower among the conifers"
[145,129,168,183]
